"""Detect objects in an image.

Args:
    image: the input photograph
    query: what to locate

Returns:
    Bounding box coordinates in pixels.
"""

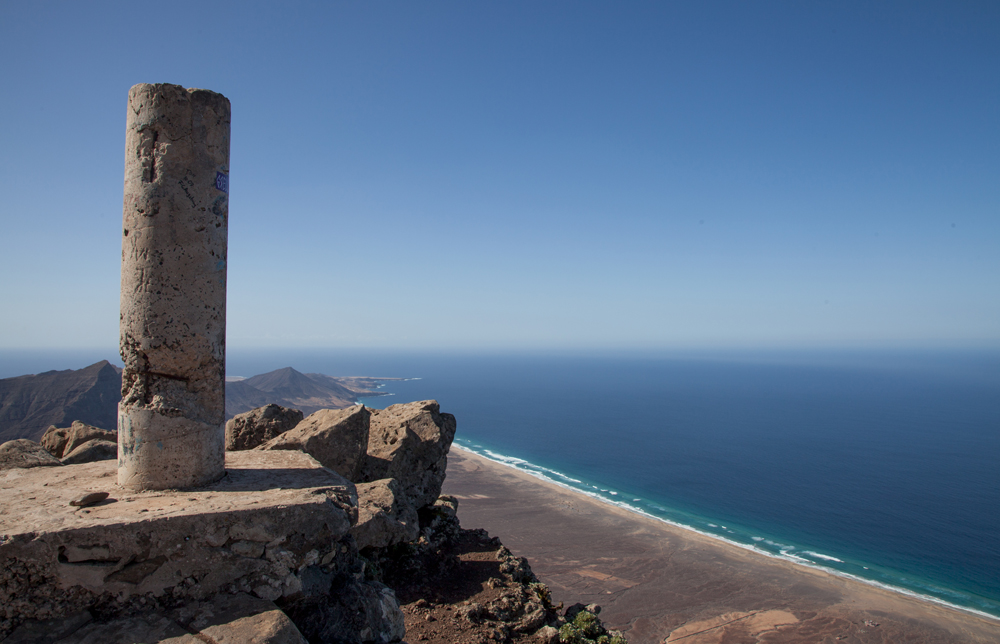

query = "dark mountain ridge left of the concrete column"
[0,360,122,441]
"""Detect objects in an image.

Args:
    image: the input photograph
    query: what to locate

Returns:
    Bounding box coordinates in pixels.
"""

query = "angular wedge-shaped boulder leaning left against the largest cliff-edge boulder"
[256,405,370,481]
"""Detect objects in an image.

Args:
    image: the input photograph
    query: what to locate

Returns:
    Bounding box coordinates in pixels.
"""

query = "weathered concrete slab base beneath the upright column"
[0,451,357,637]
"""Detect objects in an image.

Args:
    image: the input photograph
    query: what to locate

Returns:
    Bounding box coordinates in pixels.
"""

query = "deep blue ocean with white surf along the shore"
[0,349,1000,616]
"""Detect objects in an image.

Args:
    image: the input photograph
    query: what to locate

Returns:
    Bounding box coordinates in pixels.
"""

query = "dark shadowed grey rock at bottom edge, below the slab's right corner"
[285,579,406,644]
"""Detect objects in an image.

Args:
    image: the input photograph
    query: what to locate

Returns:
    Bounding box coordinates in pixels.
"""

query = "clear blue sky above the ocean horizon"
[0,0,1000,350]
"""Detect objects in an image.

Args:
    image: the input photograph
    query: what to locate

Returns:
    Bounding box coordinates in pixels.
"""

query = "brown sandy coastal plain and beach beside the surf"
[444,446,1000,644]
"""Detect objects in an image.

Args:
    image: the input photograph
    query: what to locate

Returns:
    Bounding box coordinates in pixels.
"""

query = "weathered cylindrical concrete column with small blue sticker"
[118,83,230,490]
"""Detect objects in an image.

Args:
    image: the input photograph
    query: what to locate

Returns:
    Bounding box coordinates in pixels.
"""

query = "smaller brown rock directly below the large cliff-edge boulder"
[351,479,420,549]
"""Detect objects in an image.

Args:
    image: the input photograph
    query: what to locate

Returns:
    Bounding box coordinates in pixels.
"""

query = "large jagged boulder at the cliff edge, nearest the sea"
[360,400,455,508]
